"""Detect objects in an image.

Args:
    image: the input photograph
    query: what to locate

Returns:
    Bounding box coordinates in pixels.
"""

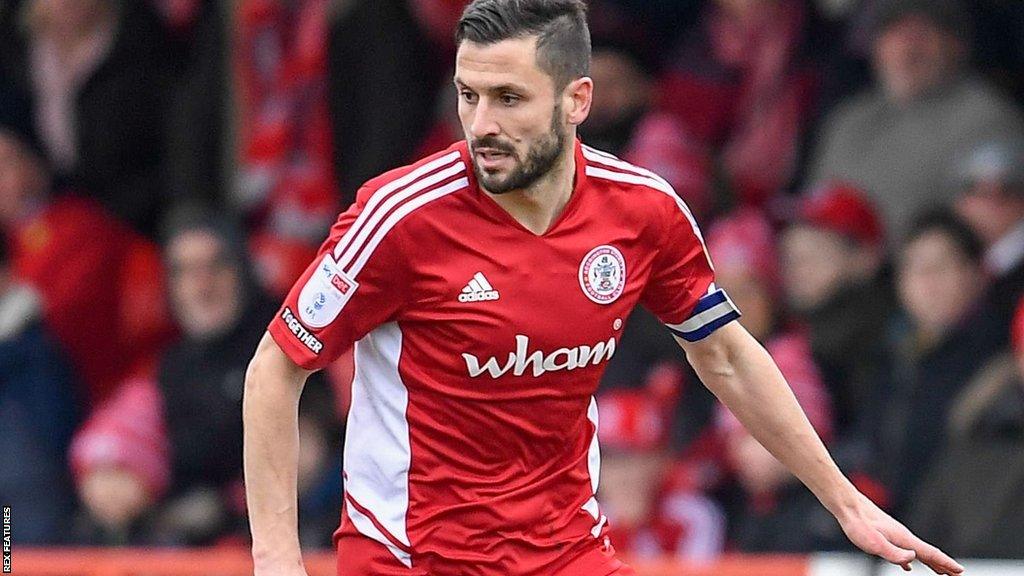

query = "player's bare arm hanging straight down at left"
[242,334,309,576]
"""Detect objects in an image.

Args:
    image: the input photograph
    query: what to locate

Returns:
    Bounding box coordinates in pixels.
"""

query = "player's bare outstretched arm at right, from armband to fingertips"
[680,322,964,575]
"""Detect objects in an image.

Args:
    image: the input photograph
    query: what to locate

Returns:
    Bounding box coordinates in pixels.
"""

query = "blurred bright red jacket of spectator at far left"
[7,197,172,403]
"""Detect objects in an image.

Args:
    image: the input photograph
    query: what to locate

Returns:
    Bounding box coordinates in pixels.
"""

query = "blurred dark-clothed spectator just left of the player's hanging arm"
[155,212,340,544]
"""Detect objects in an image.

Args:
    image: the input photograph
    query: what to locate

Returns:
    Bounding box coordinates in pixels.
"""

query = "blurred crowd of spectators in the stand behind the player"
[0,0,1024,561]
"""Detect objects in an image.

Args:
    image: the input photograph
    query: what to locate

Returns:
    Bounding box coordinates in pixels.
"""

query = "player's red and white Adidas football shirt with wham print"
[269,141,738,576]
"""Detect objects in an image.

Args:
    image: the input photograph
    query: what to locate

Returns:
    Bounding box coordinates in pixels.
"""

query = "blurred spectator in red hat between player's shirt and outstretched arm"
[597,364,726,562]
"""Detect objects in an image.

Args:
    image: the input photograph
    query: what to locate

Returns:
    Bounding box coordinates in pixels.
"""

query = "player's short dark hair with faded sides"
[455,0,591,89]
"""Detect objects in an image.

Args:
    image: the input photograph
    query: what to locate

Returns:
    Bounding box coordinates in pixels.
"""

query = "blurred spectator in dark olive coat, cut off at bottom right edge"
[909,299,1024,559]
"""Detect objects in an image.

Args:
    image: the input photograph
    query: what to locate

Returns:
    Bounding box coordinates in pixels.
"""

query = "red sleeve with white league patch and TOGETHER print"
[267,190,408,370]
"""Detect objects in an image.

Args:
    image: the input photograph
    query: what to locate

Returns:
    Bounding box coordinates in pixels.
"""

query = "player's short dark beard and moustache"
[470,106,568,194]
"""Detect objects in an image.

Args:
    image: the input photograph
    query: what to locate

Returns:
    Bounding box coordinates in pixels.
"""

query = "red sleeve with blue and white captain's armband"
[640,193,739,342]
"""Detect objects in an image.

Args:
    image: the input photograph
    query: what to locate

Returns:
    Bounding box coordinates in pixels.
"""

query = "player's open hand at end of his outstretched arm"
[837,496,964,576]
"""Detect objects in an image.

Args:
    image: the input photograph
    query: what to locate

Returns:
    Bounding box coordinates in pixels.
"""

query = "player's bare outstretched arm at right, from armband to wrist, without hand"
[687,323,860,516]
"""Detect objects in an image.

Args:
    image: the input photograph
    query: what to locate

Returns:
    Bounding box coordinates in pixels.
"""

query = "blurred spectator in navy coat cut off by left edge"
[0,234,78,548]
